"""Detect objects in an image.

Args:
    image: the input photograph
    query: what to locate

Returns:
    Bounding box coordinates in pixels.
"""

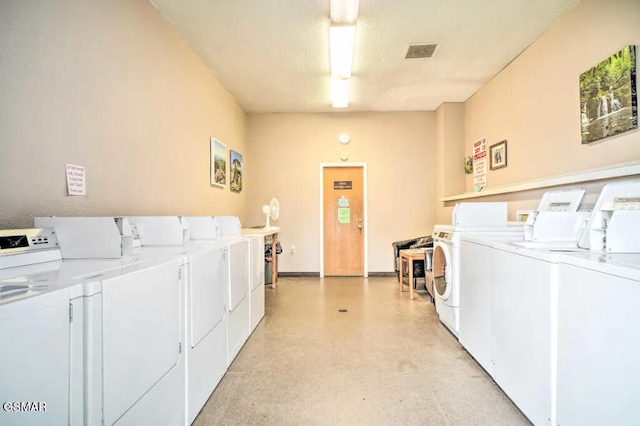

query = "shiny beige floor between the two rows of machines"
[194,277,530,426]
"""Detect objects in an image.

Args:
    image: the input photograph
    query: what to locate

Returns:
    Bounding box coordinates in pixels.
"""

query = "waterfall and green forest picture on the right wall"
[580,46,638,144]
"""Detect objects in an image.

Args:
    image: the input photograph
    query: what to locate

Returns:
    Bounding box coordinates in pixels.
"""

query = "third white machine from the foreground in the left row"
[129,216,228,424]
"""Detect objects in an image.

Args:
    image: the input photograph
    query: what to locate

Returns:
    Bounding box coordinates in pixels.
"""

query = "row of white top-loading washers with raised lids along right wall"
[459,182,640,425]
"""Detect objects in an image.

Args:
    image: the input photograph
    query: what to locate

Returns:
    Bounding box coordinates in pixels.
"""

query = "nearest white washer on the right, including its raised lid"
[557,181,640,425]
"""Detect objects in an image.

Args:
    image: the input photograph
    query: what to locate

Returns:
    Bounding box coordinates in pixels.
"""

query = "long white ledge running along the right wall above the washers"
[438,161,640,202]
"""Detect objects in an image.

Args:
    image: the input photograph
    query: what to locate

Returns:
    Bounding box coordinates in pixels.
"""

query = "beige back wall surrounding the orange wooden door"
[242,112,436,272]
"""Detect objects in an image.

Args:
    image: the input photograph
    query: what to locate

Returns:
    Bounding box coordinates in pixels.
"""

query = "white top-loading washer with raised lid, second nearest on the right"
[482,188,608,425]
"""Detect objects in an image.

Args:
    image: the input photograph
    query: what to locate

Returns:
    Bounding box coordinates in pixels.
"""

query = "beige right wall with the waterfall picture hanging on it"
[438,0,640,218]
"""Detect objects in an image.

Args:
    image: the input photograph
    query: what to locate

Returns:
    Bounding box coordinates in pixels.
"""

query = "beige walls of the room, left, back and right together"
[0,0,640,272]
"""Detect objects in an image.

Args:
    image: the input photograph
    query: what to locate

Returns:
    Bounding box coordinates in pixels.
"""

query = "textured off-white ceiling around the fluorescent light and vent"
[152,0,579,113]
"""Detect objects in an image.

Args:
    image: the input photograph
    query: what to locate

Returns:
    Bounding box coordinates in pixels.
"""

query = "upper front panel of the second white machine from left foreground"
[101,262,184,425]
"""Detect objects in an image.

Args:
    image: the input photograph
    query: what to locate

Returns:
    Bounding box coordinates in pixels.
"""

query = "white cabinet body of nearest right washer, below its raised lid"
[557,251,640,425]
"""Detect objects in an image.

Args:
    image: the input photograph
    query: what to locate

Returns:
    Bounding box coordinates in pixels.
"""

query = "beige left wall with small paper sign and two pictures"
[0,0,246,228]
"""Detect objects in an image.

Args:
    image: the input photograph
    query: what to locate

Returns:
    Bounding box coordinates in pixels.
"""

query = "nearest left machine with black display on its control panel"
[0,229,83,425]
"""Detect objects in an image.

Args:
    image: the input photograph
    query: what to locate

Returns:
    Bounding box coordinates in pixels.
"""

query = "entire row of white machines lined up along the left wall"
[0,217,264,425]
